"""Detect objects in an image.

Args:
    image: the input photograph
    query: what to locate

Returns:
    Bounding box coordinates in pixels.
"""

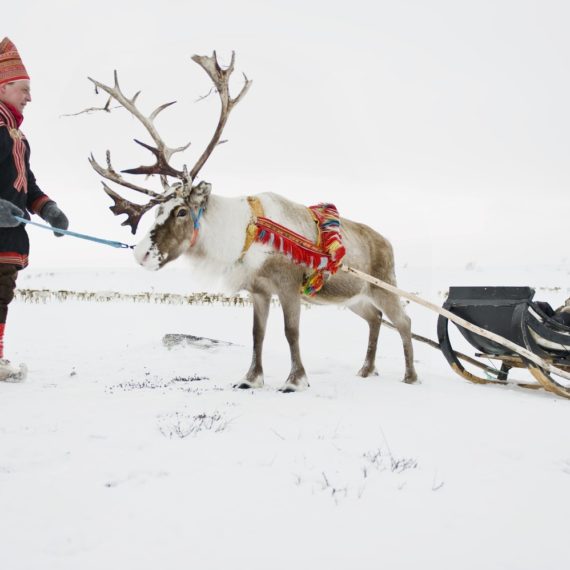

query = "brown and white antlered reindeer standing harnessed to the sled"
[89,52,417,392]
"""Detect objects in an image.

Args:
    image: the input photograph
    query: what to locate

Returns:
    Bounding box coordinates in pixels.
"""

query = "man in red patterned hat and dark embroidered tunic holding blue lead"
[0,38,69,381]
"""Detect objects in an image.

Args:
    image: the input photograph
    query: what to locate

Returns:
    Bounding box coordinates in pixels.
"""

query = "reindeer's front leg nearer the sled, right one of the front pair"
[278,287,309,393]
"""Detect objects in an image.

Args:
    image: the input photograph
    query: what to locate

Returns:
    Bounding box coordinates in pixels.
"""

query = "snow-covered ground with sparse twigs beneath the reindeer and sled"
[0,267,570,570]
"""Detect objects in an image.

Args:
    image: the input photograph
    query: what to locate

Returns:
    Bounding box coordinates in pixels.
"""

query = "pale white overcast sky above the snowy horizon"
[7,0,570,267]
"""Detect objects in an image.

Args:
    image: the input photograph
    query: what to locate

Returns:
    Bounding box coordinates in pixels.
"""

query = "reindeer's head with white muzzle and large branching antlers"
[89,52,251,270]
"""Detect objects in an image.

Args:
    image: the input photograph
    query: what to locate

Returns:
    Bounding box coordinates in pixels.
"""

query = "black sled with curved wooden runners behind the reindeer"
[437,287,570,398]
